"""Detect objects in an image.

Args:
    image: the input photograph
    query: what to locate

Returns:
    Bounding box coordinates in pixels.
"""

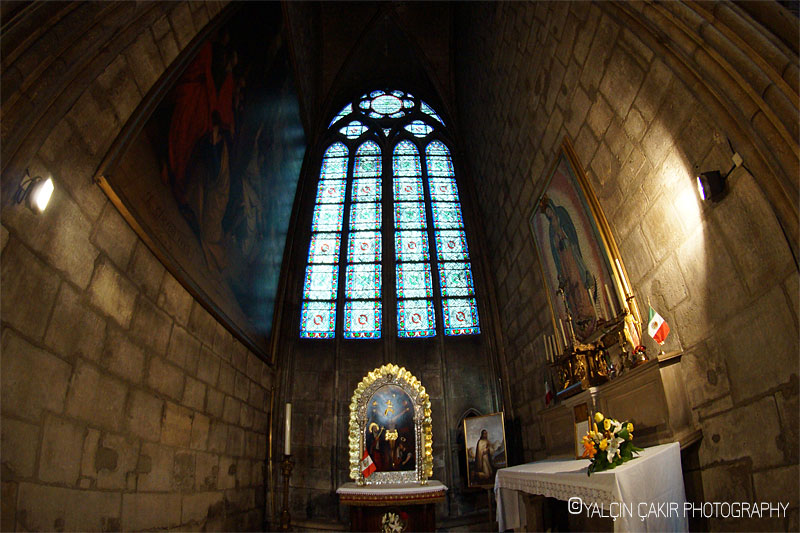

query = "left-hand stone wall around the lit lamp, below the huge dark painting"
[0,2,274,531]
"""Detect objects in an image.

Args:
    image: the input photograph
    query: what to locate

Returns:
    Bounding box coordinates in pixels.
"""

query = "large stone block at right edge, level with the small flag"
[719,287,798,402]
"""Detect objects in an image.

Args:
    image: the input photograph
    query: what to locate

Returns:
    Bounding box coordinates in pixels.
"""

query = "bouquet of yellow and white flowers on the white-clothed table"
[583,412,642,475]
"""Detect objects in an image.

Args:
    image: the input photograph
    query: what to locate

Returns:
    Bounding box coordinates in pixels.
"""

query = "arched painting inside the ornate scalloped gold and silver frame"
[364,385,417,472]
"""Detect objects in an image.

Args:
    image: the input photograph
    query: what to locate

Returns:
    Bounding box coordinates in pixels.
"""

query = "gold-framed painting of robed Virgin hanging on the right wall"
[530,140,622,342]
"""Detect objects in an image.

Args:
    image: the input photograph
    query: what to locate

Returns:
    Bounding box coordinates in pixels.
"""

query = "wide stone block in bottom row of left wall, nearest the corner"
[17,483,120,531]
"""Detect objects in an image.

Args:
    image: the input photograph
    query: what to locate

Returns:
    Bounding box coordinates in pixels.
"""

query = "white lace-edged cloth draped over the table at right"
[494,442,689,531]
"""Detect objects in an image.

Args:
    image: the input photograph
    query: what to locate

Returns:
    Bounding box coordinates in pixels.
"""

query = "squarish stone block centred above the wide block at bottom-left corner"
[38,415,86,485]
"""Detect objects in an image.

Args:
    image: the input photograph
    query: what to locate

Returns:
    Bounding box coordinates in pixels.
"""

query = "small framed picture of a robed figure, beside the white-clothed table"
[464,412,508,487]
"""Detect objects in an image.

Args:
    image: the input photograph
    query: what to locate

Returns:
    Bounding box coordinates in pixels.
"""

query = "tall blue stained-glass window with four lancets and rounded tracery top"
[300,90,480,339]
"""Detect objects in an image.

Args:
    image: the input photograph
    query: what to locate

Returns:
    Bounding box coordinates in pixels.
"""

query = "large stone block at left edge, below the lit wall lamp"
[0,239,60,339]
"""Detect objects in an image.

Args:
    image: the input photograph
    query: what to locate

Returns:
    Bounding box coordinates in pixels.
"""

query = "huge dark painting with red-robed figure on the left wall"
[98,2,306,358]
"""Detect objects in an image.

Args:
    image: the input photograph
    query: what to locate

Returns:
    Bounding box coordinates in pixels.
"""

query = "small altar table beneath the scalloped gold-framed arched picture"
[336,479,447,531]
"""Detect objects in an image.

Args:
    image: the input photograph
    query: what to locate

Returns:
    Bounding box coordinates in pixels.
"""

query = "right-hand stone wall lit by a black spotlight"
[456,2,800,530]
